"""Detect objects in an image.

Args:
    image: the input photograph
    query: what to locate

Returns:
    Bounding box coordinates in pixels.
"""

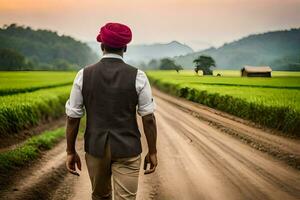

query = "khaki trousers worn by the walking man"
[85,142,141,200]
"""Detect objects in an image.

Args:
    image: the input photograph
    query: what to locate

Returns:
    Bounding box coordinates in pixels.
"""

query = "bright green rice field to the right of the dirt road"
[147,71,300,137]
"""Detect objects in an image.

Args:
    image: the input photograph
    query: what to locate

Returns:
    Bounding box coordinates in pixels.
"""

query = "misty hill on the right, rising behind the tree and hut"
[174,29,300,70]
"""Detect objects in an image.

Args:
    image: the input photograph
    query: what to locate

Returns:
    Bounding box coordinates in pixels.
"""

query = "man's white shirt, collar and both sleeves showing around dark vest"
[66,54,155,118]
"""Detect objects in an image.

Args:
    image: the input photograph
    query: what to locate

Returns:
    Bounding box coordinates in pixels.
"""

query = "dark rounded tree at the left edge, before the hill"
[0,49,26,70]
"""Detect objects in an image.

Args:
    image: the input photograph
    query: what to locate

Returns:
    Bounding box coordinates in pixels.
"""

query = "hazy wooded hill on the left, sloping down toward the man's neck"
[0,24,97,69]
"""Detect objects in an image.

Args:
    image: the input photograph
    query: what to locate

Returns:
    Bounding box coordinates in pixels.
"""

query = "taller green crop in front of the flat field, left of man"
[0,86,70,134]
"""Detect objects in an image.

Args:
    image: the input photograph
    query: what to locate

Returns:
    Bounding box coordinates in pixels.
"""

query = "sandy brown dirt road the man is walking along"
[1,92,300,200]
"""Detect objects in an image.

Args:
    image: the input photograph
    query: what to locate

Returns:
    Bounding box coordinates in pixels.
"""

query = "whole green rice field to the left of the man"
[0,72,76,135]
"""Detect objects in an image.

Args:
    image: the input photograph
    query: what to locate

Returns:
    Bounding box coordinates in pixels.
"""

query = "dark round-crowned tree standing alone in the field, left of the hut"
[193,55,216,75]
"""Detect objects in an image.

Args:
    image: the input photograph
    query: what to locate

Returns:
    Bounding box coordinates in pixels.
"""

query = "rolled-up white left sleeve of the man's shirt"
[66,69,85,118]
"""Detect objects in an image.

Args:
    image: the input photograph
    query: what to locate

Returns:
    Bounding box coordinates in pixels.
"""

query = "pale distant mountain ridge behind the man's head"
[88,41,194,64]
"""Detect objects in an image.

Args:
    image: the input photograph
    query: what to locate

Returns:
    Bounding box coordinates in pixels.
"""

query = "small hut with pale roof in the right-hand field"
[241,66,272,77]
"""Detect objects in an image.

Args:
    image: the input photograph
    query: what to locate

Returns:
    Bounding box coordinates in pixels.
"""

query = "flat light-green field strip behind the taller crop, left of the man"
[0,72,76,96]
